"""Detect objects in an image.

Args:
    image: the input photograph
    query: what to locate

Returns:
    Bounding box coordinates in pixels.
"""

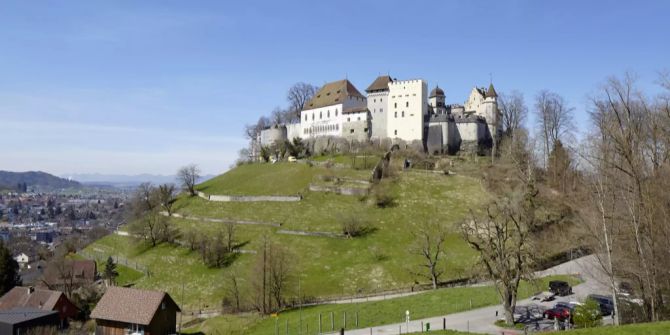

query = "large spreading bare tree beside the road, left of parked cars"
[461,181,537,325]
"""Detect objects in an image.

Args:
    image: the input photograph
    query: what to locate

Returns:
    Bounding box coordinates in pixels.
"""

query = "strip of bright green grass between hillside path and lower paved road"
[189,276,578,335]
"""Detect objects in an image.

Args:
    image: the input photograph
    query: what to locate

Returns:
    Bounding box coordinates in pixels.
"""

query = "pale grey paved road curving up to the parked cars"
[330,255,609,335]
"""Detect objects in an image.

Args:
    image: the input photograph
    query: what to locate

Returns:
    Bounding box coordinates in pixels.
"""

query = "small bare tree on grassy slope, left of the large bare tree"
[410,222,447,290]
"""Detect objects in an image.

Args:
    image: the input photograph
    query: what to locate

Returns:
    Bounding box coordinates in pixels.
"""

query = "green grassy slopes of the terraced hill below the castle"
[87,159,489,310]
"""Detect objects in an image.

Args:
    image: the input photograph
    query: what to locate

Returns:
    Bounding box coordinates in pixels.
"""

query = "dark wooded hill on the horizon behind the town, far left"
[0,171,81,191]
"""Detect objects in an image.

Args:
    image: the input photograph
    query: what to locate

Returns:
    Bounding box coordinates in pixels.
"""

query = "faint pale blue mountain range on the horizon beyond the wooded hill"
[63,173,214,186]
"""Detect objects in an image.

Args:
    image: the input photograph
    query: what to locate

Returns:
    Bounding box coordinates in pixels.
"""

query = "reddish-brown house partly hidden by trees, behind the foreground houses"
[42,259,98,293]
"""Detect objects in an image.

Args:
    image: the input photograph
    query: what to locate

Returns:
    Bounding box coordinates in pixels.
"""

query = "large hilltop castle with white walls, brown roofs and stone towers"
[256,75,501,154]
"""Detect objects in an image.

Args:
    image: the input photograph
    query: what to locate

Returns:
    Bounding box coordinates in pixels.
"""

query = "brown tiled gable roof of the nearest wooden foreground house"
[91,286,181,325]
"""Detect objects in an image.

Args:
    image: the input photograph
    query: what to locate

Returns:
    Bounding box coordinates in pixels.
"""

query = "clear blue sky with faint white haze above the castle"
[0,1,670,175]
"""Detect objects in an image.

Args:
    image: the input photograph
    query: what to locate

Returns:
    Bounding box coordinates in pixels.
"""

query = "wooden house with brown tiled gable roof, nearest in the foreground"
[91,286,181,335]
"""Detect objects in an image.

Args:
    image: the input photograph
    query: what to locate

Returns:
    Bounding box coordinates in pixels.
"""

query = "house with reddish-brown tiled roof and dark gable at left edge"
[0,286,79,326]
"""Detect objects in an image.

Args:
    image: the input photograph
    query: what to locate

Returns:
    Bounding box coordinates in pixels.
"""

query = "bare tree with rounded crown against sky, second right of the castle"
[535,90,574,166]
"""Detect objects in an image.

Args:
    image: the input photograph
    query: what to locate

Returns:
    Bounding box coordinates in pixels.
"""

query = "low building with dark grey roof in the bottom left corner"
[0,308,60,335]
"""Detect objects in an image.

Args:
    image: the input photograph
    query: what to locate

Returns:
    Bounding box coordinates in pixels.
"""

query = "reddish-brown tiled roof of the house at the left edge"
[0,286,63,311]
